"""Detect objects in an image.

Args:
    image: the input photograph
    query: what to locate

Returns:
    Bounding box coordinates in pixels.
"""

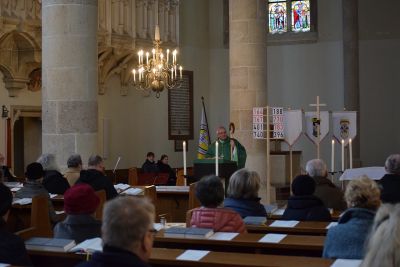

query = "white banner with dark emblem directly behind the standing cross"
[304,111,329,148]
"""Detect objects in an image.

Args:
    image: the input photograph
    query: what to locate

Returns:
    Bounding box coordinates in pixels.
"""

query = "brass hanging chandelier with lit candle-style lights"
[132,22,182,98]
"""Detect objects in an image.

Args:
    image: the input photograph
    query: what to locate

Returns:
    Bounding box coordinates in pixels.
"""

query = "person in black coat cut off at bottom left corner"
[0,184,32,266]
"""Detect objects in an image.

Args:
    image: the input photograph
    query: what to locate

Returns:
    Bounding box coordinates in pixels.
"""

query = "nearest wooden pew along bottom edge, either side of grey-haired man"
[28,248,335,267]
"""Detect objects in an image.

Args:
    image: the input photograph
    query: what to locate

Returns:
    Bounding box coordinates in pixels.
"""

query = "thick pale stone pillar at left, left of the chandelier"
[42,0,98,170]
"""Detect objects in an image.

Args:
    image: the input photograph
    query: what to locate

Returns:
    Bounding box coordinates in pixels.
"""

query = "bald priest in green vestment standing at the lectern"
[206,126,247,170]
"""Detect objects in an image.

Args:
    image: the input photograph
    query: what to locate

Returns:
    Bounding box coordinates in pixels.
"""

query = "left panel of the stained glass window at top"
[268,0,287,33]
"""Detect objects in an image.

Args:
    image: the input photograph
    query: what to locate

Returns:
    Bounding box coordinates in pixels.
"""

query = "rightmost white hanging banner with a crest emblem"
[332,111,357,147]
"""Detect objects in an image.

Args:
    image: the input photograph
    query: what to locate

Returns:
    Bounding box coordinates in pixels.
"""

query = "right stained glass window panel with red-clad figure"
[292,1,310,32]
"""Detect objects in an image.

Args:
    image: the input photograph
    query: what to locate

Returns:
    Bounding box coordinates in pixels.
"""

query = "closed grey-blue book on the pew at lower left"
[25,240,76,251]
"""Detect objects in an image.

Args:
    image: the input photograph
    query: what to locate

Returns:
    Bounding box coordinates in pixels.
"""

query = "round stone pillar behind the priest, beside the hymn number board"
[229,0,273,203]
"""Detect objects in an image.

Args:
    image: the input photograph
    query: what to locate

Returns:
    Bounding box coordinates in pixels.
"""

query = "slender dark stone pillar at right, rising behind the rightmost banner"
[343,0,362,168]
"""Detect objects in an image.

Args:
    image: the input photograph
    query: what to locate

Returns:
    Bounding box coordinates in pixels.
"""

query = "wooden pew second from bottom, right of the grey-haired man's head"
[153,230,325,257]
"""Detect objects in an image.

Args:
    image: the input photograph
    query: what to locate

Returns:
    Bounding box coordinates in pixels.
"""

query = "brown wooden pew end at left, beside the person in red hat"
[4,194,53,238]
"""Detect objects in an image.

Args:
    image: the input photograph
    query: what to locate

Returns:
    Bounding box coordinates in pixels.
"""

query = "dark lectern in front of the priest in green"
[194,159,237,195]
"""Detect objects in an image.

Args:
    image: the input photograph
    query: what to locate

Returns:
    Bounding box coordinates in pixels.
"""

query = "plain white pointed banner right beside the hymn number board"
[283,110,303,147]
